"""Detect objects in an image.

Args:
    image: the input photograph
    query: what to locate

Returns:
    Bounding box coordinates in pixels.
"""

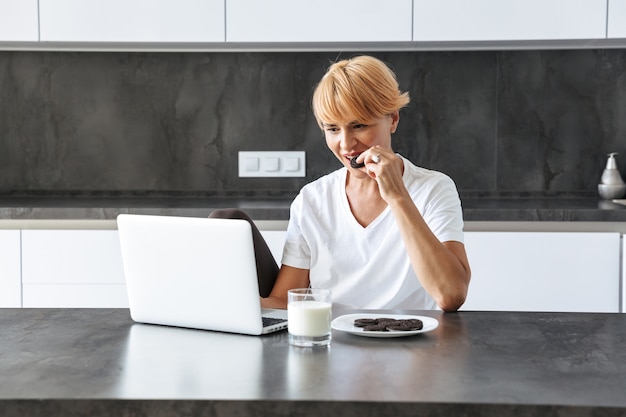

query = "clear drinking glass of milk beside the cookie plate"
[287,288,332,347]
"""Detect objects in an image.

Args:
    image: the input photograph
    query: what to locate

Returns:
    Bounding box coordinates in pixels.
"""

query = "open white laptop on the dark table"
[117,214,287,335]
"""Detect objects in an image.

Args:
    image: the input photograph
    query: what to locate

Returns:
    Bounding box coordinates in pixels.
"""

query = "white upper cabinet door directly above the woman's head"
[226,0,412,42]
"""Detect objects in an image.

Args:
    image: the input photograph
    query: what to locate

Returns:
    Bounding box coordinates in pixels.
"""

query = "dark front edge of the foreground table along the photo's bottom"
[0,398,626,417]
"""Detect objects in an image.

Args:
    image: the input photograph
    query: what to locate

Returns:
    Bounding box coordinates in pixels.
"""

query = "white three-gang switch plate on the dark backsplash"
[239,151,306,177]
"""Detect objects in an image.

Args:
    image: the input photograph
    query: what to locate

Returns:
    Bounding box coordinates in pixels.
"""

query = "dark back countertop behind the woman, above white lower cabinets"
[0,196,626,222]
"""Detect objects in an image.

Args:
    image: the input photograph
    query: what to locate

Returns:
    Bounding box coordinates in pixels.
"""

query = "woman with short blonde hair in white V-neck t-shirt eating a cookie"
[214,56,470,311]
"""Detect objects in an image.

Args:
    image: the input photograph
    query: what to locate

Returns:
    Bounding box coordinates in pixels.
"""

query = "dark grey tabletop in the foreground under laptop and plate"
[0,309,626,417]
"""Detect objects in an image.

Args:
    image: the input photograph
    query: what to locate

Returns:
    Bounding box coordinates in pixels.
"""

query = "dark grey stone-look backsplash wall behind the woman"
[0,49,626,195]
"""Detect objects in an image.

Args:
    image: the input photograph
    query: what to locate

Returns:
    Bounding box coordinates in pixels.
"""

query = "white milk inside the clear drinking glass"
[287,301,332,337]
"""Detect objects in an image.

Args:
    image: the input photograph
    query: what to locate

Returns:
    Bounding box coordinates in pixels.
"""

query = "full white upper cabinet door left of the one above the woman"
[39,0,224,42]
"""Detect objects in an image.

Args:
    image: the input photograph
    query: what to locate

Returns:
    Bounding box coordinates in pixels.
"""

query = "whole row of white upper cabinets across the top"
[0,0,626,51]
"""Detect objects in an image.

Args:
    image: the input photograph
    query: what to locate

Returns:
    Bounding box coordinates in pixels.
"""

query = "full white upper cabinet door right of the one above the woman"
[413,0,606,41]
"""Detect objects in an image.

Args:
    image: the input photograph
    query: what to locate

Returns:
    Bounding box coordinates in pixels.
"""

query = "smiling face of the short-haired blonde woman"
[322,112,399,171]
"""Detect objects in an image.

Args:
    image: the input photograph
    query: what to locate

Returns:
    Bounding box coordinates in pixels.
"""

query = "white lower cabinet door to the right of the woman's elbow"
[462,232,620,312]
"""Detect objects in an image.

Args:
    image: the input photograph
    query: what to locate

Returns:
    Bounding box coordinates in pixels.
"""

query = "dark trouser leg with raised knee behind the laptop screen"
[209,209,278,297]
